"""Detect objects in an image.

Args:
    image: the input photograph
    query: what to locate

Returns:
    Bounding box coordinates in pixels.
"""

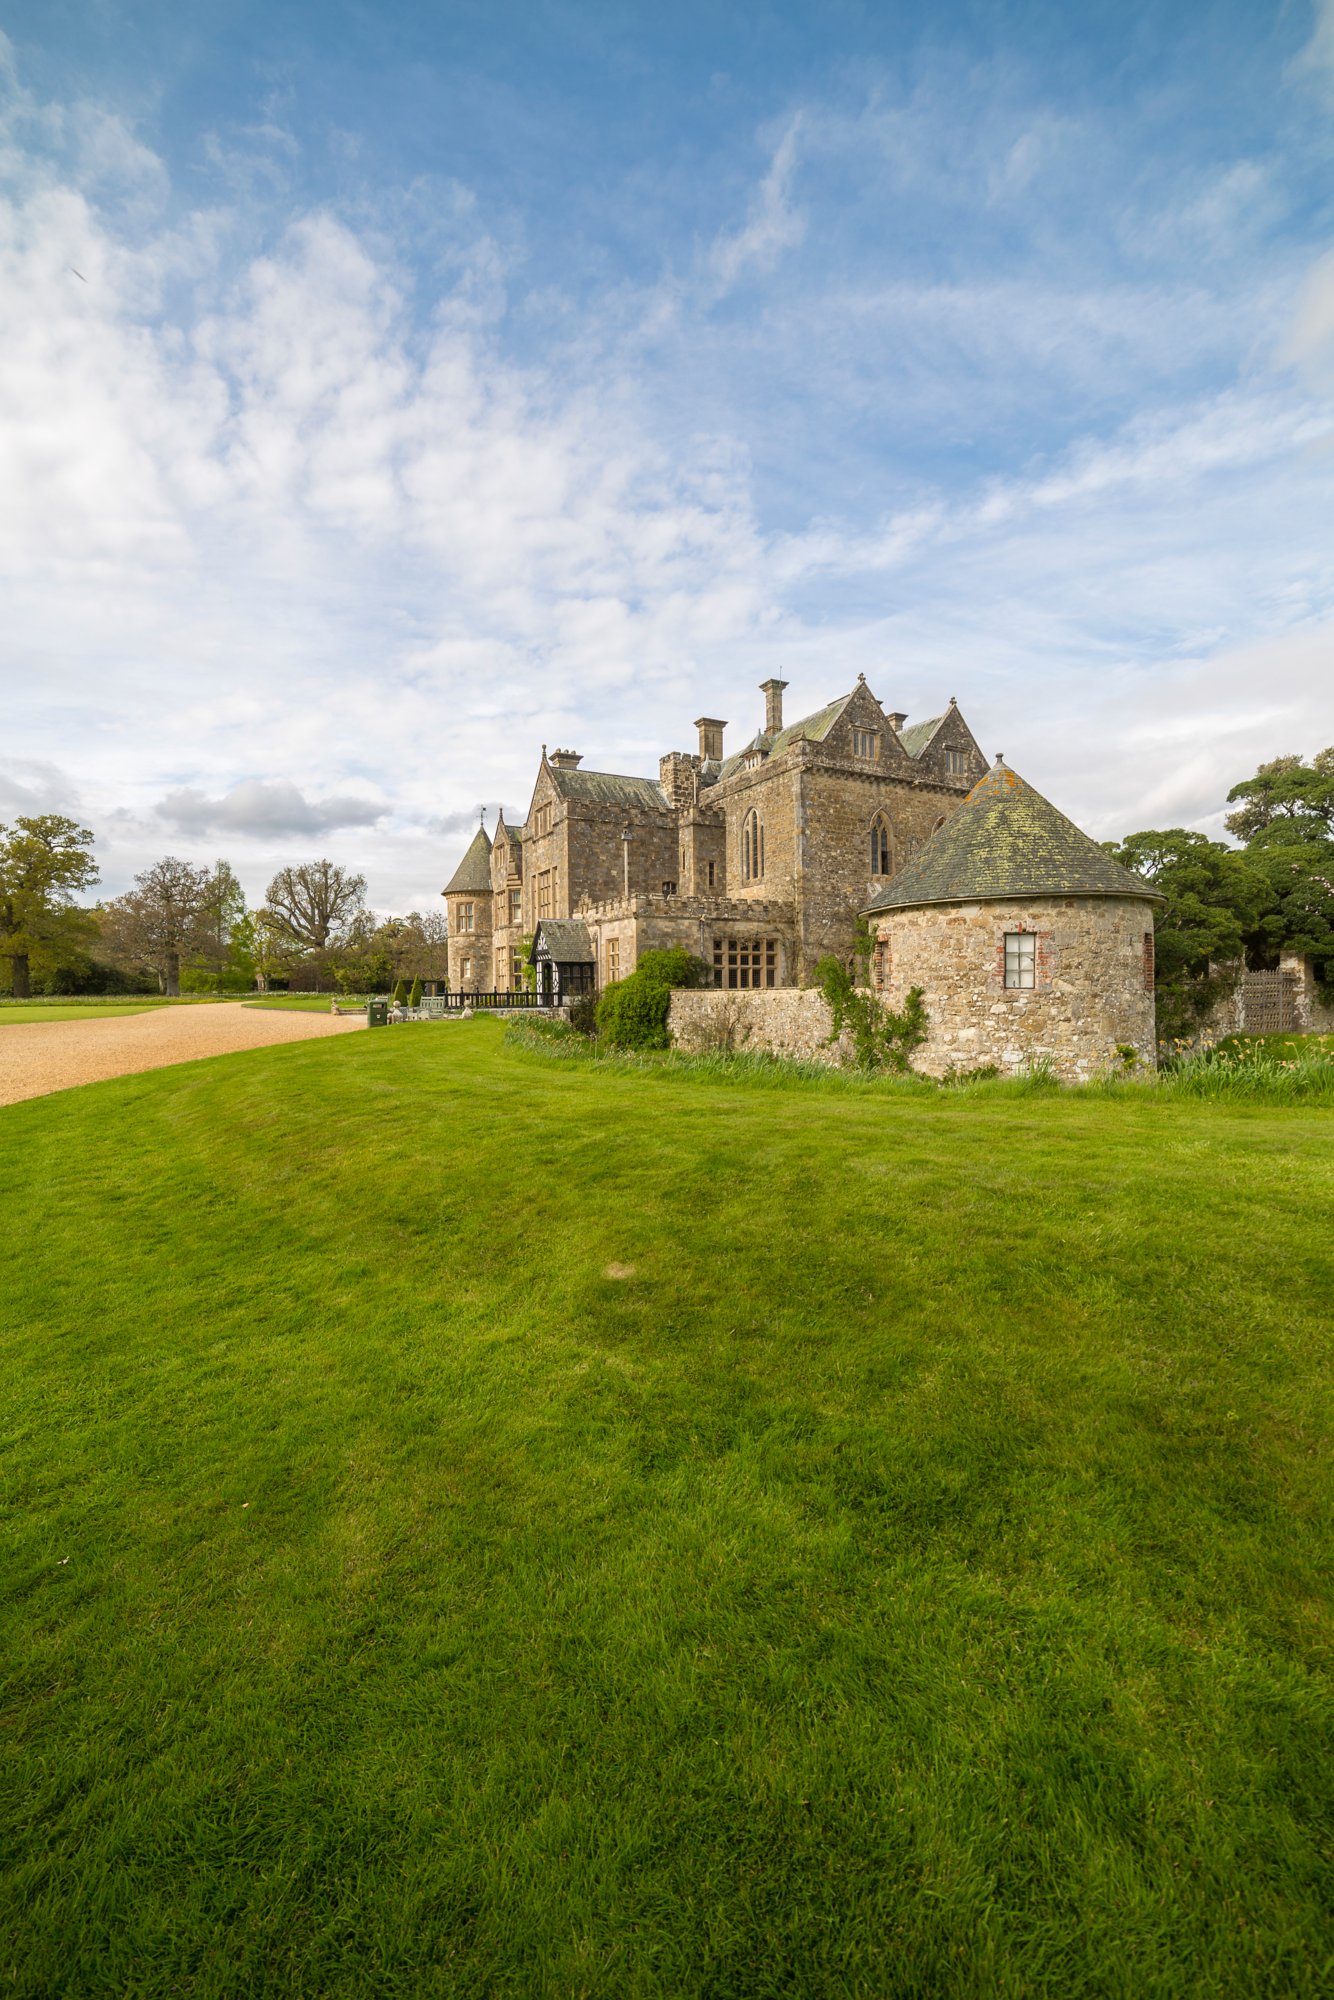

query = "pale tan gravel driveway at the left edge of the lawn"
[0,1002,366,1104]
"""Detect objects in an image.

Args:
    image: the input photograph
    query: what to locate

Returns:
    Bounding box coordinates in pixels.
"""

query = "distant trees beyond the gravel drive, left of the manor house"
[0,832,448,1000]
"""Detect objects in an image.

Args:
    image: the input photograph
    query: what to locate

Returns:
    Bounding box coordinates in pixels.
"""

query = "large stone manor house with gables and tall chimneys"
[444,676,988,1000]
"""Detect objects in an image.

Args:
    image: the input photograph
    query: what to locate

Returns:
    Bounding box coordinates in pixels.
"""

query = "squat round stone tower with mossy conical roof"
[866,758,1162,1082]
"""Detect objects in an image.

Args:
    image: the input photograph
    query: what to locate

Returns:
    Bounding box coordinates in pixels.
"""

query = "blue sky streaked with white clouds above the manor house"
[0,0,1334,908]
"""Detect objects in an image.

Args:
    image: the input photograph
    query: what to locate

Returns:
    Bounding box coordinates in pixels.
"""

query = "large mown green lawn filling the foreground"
[0,1018,1334,2000]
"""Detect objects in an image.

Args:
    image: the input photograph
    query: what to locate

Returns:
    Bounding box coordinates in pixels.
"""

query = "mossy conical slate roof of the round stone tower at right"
[866,758,1162,912]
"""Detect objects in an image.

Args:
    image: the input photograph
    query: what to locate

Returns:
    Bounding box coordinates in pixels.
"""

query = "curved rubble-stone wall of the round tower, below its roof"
[874,896,1156,1082]
